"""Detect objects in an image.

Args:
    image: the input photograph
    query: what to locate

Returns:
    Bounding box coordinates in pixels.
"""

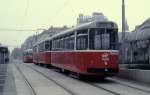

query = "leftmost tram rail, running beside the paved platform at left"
[15,63,37,95]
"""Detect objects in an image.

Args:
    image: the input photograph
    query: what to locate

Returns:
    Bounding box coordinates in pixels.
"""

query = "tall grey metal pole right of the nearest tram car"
[122,0,126,63]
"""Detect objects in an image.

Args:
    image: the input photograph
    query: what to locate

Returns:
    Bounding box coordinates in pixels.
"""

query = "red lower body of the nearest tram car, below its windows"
[51,51,118,76]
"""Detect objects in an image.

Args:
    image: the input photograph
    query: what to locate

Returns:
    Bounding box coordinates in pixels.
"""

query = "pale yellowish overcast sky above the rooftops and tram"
[0,0,150,48]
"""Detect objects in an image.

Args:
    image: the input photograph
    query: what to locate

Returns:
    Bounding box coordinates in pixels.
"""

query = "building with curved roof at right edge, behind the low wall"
[119,18,150,64]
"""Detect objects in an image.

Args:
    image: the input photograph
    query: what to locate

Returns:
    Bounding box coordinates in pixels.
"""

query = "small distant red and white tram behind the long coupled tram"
[23,49,33,63]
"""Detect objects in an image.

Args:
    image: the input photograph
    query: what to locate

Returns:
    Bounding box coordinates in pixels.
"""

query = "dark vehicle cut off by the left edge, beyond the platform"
[0,46,9,64]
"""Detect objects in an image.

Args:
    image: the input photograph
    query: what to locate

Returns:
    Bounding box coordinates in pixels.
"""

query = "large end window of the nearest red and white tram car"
[89,28,118,50]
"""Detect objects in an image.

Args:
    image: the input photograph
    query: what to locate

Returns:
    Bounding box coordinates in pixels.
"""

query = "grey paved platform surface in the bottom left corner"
[0,64,17,95]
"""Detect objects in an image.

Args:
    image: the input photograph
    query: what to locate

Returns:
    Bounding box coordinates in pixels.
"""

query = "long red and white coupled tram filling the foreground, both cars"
[33,21,119,77]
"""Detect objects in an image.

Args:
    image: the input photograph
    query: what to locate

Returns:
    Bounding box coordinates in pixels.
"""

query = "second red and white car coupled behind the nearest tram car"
[33,38,52,66]
